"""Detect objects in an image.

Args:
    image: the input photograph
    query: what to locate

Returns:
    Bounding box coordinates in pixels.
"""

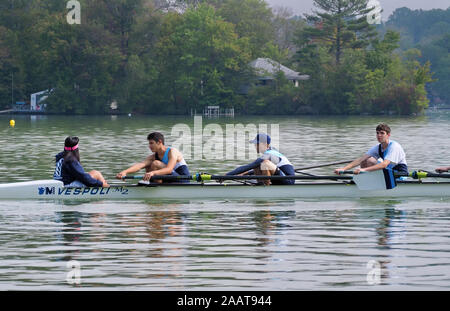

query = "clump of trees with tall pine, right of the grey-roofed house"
[296,0,432,114]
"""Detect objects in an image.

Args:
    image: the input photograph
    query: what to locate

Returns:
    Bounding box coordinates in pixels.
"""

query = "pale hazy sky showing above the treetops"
[266,0,450,21]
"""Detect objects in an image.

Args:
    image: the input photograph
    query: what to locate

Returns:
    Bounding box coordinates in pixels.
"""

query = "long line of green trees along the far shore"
[0,0,440,114]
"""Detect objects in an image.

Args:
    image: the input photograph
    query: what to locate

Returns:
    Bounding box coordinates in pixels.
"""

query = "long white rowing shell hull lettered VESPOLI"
[0,180,450,200]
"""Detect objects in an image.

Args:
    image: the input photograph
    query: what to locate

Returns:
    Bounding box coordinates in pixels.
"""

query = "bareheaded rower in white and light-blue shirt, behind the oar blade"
[334,123,408,178]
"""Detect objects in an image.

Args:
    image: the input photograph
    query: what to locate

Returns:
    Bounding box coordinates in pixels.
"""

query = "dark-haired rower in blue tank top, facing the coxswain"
[116,132,190,182]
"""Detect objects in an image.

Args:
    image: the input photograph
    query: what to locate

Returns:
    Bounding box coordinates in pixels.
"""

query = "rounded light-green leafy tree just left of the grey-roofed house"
[150,5,250,113]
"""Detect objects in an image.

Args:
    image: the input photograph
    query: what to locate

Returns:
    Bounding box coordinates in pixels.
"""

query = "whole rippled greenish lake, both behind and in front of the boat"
[0,112,450,290]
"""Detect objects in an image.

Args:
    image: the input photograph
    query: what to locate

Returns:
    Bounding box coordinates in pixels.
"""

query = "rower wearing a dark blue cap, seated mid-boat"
[226,133,295,185]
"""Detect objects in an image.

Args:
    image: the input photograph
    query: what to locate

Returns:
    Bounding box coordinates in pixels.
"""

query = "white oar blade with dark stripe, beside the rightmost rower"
[353,169,397,190]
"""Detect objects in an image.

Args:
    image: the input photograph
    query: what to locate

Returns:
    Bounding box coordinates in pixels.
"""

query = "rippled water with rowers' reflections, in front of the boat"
[0,200,450,290]
